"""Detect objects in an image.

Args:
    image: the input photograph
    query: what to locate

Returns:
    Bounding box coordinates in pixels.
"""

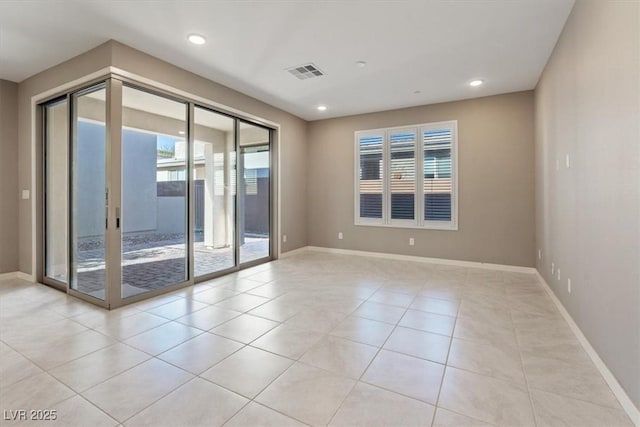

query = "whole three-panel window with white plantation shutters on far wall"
[355,121,457,230]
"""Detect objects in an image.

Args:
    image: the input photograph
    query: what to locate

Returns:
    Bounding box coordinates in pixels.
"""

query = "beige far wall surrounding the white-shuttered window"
[307,92,535,266]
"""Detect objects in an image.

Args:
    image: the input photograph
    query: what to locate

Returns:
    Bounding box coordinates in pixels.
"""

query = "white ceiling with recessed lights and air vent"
[0,0,574,120]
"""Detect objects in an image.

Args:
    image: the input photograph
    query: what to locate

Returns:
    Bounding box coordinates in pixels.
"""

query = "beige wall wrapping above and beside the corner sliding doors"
[18,41,307,273]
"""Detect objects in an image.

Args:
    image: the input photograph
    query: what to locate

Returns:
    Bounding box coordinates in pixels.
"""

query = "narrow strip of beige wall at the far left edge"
[0,80,19,274]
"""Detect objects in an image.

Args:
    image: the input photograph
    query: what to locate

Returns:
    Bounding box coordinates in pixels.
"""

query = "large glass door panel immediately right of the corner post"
[120,85,189,298]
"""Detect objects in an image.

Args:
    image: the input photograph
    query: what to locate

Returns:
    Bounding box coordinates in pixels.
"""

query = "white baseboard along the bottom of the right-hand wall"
[536,270,640,427]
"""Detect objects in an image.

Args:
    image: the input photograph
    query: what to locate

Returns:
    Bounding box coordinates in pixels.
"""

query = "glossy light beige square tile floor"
[0,252,632,427]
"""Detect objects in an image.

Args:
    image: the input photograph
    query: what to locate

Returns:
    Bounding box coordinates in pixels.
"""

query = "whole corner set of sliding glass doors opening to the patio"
[42,78,272,307]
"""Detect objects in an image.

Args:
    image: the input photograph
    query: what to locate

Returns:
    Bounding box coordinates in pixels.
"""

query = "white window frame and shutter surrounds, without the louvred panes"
[354,120,458,231]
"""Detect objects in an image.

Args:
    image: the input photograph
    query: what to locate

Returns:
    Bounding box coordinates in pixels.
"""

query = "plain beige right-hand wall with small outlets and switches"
[535,0,640,407]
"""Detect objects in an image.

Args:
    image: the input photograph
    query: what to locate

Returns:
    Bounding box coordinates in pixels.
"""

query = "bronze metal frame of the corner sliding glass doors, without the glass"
[39,72,280,309]
